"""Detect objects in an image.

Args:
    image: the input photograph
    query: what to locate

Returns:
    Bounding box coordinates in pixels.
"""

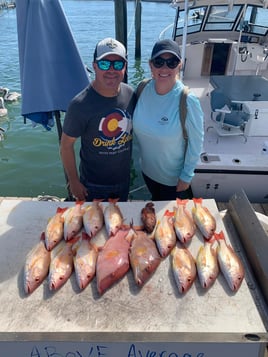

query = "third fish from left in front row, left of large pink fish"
[72,231,98,290]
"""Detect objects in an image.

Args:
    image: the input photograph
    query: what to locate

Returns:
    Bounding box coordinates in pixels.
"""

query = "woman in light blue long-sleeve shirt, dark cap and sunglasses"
[133,40,204,201]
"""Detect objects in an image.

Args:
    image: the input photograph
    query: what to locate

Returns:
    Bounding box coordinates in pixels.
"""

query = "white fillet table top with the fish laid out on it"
[0,199,267,357]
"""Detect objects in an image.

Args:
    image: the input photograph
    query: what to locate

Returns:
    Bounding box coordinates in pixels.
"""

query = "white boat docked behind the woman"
[168,0,268,203]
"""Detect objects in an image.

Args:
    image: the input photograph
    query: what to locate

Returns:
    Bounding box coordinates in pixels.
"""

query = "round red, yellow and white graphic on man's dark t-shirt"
[96,109,132,150]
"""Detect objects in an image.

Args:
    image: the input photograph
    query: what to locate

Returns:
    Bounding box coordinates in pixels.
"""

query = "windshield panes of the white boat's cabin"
[173,4,268,39]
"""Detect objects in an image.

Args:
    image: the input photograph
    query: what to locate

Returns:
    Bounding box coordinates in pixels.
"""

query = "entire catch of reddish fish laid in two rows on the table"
[24,200,243,294]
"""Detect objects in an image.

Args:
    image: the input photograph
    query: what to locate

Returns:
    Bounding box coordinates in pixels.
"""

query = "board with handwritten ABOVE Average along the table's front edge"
[0,341,265,357]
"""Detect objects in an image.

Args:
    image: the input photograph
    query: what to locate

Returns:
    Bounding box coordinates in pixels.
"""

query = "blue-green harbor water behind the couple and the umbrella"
[0,0,175,199]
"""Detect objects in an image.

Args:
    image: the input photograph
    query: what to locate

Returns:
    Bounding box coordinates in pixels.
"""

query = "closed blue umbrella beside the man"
[16,0,89,131]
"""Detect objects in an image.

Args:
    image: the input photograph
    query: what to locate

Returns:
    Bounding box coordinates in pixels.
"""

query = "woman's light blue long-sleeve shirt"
[133,80,204,186]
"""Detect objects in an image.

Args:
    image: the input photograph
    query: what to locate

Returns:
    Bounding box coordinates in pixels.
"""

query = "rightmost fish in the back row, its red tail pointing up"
[192,198,216,240]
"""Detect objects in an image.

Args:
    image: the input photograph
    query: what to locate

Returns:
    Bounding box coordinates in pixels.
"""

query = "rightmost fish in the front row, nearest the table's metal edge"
[214,231,245,291]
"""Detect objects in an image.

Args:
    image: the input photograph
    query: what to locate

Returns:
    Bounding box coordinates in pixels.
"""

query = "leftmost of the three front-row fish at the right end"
[171,245,197,294]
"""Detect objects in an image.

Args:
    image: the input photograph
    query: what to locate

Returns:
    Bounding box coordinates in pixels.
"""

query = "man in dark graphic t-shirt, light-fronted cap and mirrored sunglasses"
[60,38,136,201]
